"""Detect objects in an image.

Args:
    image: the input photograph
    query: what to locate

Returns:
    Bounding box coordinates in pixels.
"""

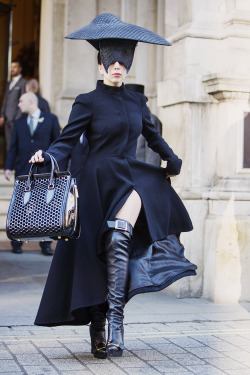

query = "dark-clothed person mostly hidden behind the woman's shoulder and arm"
[125,83,162,167]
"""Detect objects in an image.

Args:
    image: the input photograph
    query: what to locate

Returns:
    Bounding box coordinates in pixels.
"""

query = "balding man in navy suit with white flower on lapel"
[4,92,62,255]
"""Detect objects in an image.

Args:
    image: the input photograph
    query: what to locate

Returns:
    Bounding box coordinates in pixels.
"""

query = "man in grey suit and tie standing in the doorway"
[0,60,26,151]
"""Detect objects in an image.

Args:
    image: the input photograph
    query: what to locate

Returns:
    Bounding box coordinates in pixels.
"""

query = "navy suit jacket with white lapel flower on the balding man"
[4,112,60,176]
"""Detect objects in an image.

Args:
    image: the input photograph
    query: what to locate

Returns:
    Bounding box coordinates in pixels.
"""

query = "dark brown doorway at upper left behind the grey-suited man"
[0,0,41,168]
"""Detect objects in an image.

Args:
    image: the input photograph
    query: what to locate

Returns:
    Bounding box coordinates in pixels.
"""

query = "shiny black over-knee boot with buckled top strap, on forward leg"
[105,219,133,357]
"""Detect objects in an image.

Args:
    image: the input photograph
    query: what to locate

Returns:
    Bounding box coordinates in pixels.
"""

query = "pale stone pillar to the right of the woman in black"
[158,0,250,302]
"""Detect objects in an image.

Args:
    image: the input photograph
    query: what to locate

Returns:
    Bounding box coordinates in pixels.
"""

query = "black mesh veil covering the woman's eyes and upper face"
[99,39,137,73]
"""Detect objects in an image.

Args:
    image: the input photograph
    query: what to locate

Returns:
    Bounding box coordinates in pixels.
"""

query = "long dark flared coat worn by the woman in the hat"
[35,81,196,325]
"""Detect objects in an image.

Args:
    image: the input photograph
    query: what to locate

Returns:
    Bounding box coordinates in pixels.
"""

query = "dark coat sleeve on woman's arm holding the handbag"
[43,94,92,164]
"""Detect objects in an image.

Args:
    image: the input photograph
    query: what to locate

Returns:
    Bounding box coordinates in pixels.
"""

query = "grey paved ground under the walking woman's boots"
[0,251,250,375]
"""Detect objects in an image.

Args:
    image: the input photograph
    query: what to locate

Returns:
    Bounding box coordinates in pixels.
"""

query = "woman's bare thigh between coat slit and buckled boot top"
[115,190,141,227]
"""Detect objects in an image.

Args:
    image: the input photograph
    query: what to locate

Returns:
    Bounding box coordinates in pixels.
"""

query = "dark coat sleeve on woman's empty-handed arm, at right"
[141,95,182,175]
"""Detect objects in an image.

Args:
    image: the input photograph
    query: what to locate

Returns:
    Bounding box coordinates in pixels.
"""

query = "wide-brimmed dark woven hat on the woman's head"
[66,13,171,50]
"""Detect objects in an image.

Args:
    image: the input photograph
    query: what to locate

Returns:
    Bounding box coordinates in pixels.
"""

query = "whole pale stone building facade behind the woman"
[40,0,250,303]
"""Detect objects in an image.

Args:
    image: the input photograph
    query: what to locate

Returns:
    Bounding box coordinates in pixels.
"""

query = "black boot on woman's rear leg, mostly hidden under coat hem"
[89,304,107,359]
